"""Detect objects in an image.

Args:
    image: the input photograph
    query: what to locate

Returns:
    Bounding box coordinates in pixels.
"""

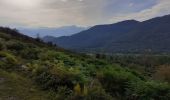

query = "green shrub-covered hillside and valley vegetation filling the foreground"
[0,28,170,100]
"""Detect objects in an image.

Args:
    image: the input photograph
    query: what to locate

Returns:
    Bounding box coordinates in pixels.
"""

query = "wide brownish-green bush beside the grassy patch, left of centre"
[33,65,85,91]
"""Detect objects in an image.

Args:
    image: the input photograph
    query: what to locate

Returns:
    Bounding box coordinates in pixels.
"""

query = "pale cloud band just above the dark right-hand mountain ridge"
[110,0,170,22]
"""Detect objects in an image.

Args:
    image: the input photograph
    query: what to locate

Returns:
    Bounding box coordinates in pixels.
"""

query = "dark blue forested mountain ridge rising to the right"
[44,15,170,53]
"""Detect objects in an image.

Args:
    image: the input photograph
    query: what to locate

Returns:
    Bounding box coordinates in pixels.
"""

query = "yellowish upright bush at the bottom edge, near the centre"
[71,79,114,100]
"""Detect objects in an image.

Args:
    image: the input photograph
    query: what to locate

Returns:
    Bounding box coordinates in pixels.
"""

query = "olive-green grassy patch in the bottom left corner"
[0,70,48,100]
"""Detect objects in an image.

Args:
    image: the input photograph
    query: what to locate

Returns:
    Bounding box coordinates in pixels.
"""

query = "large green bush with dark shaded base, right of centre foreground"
[97,68,140,97]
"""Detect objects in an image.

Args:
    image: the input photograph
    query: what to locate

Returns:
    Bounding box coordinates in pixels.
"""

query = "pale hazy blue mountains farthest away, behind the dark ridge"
[19,25,87,37]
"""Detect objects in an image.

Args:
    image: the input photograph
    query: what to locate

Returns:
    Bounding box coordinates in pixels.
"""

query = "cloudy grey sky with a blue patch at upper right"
[0,0,170,27]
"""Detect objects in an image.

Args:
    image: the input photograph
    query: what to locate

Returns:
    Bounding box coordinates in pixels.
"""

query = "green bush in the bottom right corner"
[128,81,170,100]
